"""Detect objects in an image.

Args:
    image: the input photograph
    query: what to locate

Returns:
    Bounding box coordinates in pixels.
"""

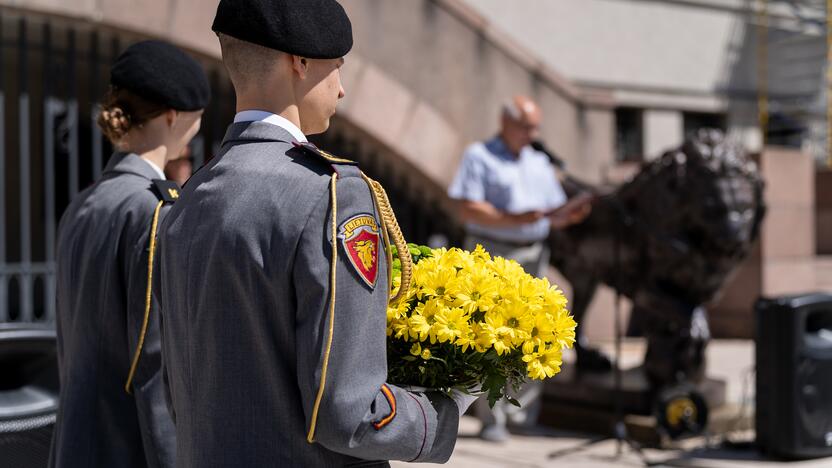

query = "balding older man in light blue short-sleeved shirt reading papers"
[448,96,589,441]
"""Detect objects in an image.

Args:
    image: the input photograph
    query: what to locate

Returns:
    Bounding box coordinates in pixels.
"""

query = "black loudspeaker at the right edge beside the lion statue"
[755,293,832,459]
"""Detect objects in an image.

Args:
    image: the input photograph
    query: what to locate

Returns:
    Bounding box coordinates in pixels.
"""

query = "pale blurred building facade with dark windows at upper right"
[465,0,827,165]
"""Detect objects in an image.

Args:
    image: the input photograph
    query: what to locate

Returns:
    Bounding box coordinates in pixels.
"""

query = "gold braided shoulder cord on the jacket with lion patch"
[306,173,413,444]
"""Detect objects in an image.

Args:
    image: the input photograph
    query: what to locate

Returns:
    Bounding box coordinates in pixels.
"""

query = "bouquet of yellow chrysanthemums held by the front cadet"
[387,244,576,406]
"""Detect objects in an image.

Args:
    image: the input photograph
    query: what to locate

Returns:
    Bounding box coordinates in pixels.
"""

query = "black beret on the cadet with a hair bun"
[110,41,211,111]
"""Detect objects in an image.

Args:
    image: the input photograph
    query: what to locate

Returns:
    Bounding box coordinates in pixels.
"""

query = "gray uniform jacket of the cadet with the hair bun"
[50,154,176,468]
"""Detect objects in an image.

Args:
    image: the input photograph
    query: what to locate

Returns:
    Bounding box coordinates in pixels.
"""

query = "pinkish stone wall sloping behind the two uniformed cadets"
[0,0,614,194]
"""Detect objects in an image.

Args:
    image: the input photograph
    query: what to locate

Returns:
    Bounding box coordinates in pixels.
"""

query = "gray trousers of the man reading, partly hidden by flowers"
[464,235,549,427]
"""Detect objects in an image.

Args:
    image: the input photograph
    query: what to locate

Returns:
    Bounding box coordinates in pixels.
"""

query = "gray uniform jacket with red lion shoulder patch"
[159,122,459,468]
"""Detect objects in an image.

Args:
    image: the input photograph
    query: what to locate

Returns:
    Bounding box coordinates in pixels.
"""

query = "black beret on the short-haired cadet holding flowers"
[211,0,352,59]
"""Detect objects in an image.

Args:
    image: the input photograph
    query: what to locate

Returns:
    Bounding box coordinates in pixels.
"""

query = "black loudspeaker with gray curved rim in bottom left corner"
[0,323,58,468]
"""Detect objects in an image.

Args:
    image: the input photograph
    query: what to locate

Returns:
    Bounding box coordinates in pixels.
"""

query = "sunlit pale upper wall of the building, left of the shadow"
[466,0,741,93]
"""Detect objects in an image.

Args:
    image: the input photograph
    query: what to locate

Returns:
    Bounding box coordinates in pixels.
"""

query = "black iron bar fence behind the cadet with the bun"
[0,8,234,323]
